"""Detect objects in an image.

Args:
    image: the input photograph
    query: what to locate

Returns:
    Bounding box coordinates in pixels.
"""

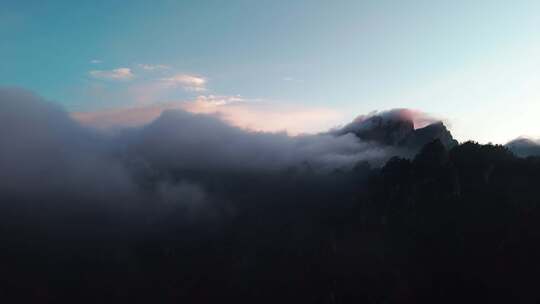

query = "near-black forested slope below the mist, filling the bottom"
[0,141,540,303]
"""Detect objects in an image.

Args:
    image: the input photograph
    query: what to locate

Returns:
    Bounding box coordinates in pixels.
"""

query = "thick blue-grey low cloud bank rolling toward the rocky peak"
[0,89,396,224]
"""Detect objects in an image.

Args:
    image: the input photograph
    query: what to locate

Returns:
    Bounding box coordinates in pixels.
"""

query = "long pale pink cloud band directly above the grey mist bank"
[72,95,343,135]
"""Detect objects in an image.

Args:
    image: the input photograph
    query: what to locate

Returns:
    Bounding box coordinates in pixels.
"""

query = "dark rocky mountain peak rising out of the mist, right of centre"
[336,111,458,151]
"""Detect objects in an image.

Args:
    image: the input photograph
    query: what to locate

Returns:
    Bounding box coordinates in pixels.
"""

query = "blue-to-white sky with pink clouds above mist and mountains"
[0,0,540,143]
